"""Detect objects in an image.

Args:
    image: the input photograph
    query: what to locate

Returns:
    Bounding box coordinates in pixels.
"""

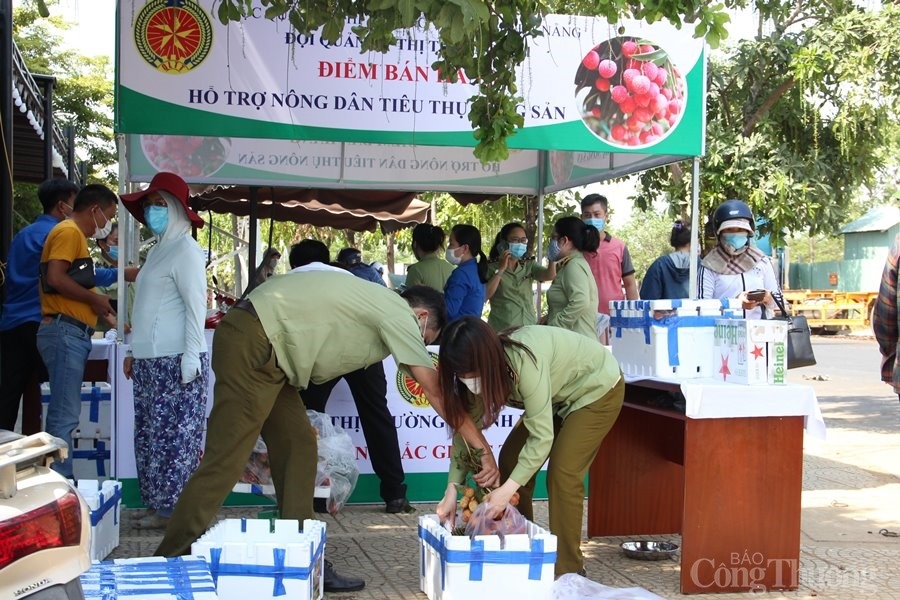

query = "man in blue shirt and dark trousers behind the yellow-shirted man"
[0,177,78,435]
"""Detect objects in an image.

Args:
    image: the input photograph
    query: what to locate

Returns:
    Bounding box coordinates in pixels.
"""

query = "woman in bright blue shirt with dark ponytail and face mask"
[444,224,488,323]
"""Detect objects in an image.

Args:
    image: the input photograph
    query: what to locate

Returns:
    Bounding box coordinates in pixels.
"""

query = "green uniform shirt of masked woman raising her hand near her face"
[488,260,547,331]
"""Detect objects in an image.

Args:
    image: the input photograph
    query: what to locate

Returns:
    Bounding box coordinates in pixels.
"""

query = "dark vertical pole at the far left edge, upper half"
[0,0,13,265]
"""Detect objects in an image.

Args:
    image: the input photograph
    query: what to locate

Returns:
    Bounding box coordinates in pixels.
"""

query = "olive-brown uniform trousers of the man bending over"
[156,308,318,556]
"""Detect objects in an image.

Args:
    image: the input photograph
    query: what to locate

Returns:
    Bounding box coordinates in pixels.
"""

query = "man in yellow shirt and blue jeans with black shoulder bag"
[37,185,137,479]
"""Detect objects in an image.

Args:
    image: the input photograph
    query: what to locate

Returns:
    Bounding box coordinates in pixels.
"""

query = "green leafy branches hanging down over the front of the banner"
[216,0,746,162]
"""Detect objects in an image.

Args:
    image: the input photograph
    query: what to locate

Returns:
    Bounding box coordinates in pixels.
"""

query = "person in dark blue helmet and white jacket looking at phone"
[698,200,780,319]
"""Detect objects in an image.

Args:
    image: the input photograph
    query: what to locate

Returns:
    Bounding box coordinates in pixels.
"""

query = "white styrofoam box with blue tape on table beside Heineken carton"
[609,299,743,379]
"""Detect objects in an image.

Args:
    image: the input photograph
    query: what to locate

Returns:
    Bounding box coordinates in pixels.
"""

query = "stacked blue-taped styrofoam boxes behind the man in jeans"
[41,381,112,480]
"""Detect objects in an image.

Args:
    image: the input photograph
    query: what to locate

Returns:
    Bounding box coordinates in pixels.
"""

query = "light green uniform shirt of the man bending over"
[247,271,434,390]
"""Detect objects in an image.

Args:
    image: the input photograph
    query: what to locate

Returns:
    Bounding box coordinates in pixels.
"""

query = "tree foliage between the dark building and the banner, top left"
[13,0,118,186]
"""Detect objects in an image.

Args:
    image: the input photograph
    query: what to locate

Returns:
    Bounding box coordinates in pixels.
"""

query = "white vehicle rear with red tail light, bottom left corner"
[0,430,91,600]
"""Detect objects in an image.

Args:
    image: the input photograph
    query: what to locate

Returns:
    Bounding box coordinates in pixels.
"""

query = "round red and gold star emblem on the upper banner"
[134,0,212,75]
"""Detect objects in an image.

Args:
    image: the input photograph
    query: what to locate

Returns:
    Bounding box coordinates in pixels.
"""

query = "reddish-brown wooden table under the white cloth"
[588,381,804,594]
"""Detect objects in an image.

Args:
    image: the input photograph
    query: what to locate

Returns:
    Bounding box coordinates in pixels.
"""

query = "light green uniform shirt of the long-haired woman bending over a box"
[448,326,621,484]
